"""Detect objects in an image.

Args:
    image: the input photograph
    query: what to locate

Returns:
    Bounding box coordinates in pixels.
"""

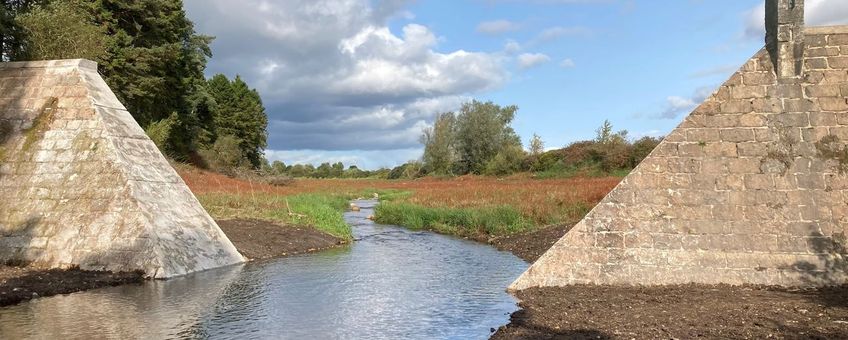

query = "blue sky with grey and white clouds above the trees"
[185,0,848,169]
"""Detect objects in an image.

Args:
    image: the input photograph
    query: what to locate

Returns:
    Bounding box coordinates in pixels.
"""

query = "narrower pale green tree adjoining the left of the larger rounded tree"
[421,112,456,175]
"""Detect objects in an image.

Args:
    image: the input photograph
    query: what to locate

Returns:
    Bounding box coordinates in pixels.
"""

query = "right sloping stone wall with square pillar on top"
[510,0,848,290]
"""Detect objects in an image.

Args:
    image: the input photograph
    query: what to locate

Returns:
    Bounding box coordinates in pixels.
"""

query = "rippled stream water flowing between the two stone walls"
[0,201,527,339]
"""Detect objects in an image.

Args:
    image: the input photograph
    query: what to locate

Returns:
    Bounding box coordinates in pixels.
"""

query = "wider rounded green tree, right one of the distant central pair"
[456,100,521,174]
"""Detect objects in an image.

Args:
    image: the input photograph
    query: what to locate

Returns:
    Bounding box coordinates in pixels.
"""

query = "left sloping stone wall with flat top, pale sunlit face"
[0,60,244,279]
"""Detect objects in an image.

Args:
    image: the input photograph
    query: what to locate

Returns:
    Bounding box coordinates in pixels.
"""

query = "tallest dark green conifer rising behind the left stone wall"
[86,0,212,128]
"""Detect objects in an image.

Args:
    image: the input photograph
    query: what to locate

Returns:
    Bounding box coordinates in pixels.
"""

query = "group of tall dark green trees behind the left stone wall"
[0,0,267,168]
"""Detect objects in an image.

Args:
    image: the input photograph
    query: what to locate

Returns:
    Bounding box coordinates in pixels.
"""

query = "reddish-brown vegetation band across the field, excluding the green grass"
[178,167,621,224]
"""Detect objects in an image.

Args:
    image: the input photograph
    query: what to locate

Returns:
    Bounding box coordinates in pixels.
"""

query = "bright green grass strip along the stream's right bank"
[375,201,533,236]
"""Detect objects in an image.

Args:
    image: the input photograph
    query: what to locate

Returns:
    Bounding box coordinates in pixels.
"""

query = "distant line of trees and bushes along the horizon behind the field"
[264,100,662,179]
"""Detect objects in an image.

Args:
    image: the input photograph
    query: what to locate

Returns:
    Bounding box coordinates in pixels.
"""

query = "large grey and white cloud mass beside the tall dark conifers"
[185,0,509,155]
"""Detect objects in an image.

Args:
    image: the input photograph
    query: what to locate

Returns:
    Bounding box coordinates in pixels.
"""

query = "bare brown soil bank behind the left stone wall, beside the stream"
[217,219,345,260]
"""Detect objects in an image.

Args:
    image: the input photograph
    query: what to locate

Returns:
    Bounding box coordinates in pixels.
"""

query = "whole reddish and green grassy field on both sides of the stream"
[177,166,621,238]
